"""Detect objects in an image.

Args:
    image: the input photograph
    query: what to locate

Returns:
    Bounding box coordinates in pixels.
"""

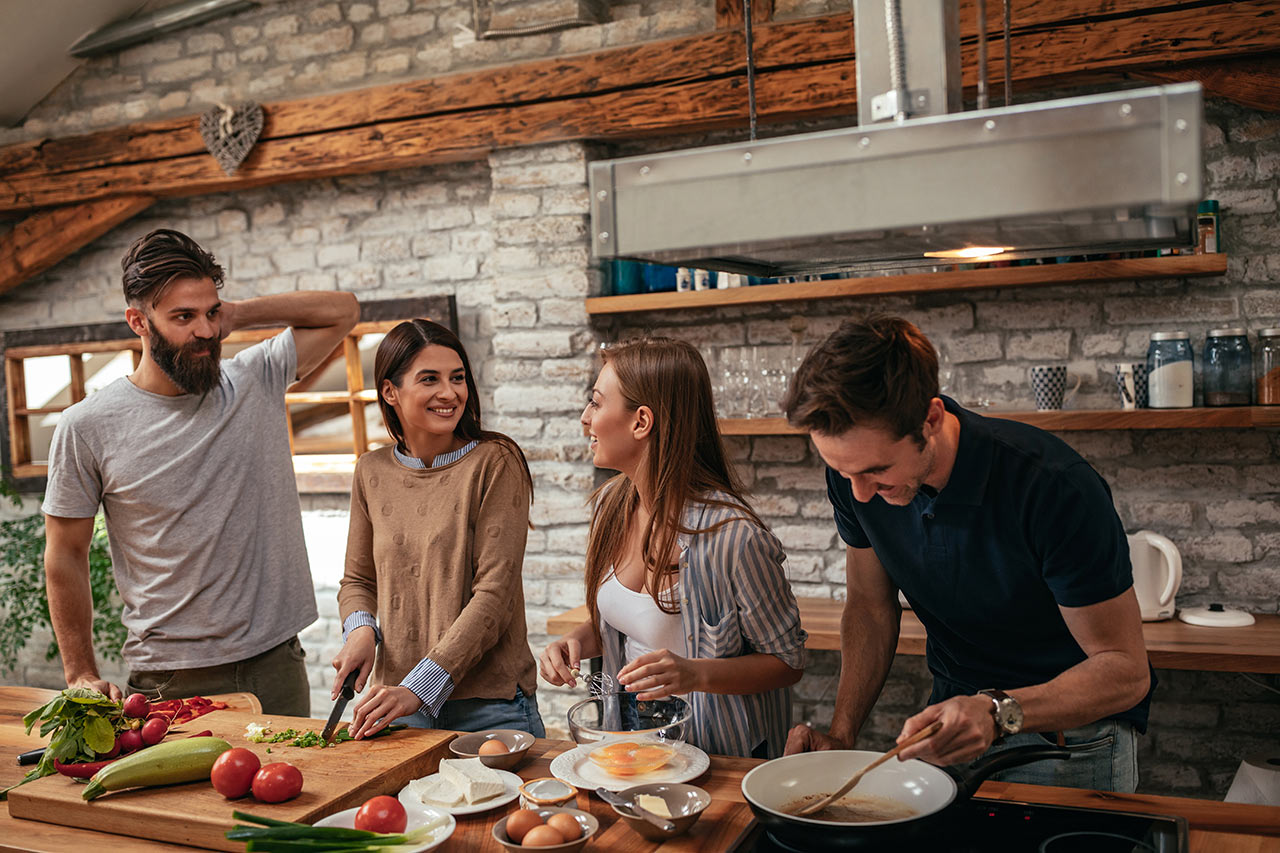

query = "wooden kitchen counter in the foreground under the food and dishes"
[0,686,1280,853]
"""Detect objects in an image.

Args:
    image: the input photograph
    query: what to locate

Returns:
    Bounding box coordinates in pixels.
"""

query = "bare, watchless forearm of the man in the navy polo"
[831,602,901,747]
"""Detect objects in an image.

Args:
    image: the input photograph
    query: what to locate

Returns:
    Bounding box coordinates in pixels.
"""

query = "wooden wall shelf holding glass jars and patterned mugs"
[718,406,1280,435]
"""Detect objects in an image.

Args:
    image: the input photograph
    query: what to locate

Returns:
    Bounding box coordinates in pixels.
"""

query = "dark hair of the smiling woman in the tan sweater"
[374,320,534,503]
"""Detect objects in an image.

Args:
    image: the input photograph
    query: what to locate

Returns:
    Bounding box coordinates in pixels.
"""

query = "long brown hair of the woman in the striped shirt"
[586,337,764,631]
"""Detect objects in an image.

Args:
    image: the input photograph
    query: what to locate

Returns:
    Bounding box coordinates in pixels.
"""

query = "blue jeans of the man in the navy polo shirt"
[987,720,1138,794]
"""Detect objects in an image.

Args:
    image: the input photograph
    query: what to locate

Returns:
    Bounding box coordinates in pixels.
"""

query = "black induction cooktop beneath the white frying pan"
[733,799,1188,853]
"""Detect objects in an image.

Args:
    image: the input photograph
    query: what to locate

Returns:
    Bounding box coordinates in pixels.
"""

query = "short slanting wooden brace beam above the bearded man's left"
[0,195,155,293]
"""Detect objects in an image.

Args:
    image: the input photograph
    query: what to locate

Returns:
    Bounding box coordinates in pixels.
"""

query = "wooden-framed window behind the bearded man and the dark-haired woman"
[0,297,457,492]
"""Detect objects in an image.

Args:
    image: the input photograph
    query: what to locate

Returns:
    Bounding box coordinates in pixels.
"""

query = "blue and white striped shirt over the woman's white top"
[600,493,806,758]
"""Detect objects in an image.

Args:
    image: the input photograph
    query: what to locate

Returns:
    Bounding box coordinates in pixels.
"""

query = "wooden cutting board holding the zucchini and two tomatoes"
[9,711,454,850]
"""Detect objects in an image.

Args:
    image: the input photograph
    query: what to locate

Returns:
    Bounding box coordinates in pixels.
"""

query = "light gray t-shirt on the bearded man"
[41,329,317,671]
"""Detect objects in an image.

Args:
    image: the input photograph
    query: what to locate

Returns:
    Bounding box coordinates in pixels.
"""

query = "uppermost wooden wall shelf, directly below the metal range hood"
[586,255,1226,315]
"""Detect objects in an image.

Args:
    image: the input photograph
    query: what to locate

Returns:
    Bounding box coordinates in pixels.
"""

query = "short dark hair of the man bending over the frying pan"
[782,315,938,442]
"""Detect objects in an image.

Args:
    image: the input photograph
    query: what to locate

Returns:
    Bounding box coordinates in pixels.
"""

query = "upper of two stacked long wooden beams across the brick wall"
[0,0,1275,186]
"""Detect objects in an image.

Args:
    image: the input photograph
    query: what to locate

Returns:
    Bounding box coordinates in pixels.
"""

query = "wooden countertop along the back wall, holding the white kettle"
[547,598,1280,672]
